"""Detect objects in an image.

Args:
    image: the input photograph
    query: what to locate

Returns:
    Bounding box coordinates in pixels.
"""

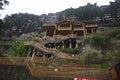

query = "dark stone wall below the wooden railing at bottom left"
[0,65,73,80]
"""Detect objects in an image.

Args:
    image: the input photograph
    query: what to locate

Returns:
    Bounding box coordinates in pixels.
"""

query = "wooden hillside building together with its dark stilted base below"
[43,20,97,48]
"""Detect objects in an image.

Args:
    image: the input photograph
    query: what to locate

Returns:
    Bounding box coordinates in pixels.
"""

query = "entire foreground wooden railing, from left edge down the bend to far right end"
[0,58,111,80]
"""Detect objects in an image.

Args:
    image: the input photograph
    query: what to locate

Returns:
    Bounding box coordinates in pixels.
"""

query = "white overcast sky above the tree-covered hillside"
[0,0,114,18]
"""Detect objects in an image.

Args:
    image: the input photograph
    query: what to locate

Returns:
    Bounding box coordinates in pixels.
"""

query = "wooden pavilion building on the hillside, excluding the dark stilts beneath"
[43,20,97,37]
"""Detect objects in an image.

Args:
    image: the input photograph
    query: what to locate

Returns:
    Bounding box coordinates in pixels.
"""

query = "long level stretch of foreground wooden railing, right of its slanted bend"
[34,67,110,79]
